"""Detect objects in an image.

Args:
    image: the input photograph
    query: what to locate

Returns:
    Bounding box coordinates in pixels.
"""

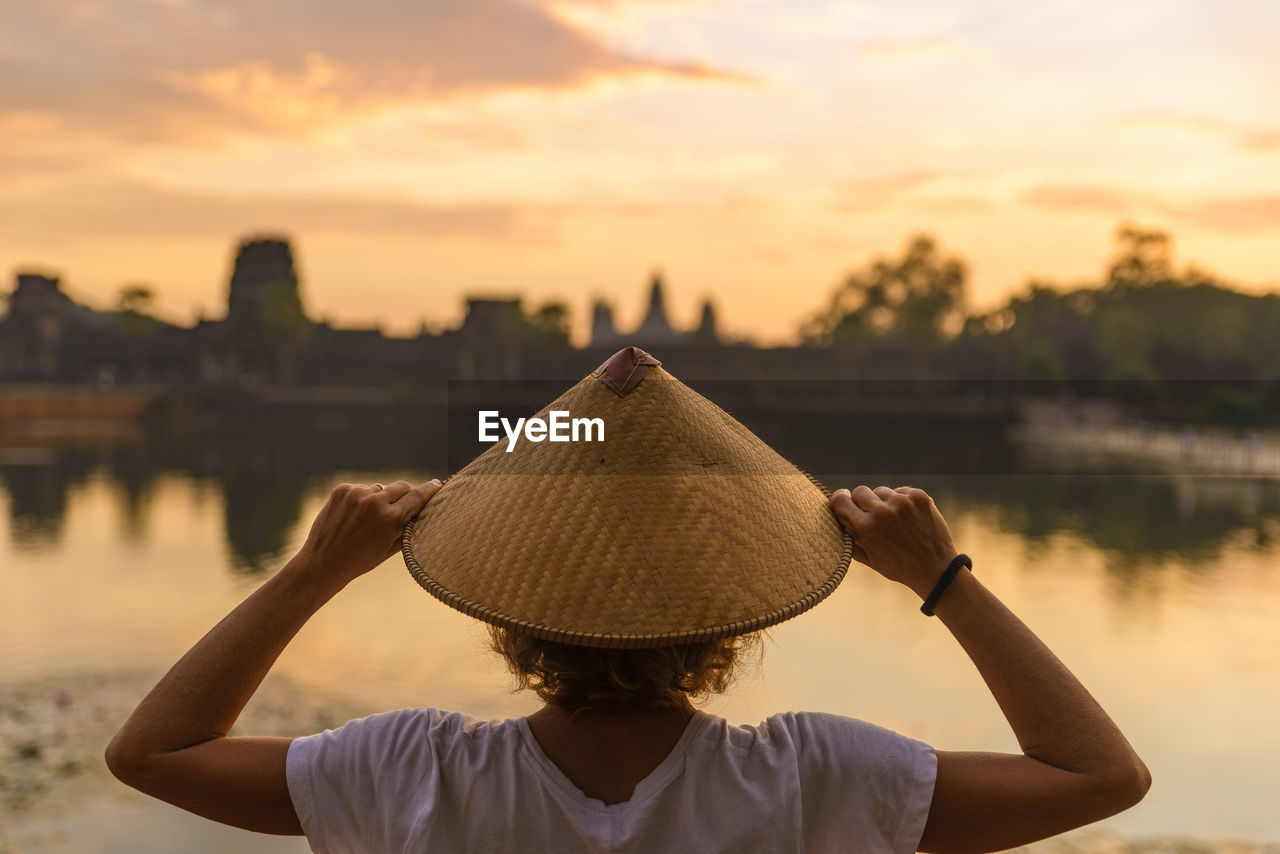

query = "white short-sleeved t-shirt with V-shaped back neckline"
[287,708,937,854]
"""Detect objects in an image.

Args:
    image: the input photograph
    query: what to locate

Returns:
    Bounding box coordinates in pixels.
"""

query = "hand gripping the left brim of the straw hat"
[298,480,440,584]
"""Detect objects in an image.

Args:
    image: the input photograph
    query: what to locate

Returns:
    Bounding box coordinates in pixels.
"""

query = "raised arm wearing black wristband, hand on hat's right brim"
[831,487,1151,854]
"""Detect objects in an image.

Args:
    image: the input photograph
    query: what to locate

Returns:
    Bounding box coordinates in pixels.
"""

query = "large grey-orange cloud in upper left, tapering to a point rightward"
[0,0,737,143]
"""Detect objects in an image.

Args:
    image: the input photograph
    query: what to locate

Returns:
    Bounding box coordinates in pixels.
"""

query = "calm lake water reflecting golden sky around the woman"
[0,430,1280,854]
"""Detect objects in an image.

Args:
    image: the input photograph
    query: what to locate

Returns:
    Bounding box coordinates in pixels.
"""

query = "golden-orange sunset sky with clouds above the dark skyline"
[0,0,1280,342]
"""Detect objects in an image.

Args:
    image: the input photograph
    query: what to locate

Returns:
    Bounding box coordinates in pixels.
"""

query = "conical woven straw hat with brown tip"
[402,347,852,648]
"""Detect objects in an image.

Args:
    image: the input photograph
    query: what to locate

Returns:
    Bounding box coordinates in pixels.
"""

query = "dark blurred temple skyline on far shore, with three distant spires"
[0,236,745,389]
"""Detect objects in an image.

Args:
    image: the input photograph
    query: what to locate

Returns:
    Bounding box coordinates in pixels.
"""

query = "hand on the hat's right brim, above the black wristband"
[831,487,959,599]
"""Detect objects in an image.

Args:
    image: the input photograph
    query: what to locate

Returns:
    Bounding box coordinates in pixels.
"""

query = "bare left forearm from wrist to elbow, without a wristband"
[108,556,340,766]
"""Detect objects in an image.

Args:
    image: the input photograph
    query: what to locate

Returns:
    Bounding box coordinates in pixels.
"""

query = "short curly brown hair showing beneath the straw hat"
[489,626,760,712]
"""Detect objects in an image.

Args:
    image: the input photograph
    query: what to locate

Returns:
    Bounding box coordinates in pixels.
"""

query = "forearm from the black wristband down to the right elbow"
[916,570,1146,777]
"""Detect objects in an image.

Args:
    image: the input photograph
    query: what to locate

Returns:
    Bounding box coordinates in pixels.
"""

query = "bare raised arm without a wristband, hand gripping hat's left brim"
[106,480,440,834]
